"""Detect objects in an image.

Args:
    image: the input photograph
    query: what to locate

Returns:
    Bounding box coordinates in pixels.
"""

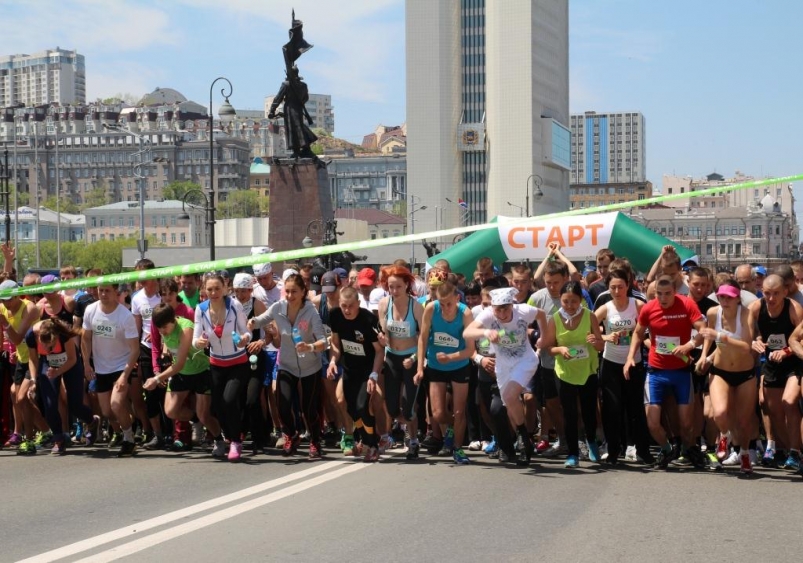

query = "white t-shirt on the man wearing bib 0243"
[83,301,139,374]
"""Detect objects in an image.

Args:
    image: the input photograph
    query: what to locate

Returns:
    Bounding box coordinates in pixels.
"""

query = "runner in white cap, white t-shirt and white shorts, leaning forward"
[463,288,547,465]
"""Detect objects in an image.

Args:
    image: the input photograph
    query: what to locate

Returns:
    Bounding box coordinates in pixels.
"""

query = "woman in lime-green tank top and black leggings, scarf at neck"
[544,282,605,468]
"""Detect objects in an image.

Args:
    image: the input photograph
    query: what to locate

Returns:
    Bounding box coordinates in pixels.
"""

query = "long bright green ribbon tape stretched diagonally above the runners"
[0,174,803,297]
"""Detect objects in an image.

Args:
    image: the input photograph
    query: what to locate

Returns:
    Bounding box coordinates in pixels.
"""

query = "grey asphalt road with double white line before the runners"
[0,448,803,562]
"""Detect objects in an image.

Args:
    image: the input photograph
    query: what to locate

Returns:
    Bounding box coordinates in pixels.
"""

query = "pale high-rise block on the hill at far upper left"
[0,47,86,107]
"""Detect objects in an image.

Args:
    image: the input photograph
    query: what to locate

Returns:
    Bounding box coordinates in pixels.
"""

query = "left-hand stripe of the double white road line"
[19,460,348,563]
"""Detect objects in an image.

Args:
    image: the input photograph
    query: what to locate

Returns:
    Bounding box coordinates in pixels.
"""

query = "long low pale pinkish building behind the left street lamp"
[85,201,209,247]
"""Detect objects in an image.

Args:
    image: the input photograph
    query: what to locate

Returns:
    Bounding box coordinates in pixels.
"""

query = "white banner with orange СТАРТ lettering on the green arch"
[498,212,619,260]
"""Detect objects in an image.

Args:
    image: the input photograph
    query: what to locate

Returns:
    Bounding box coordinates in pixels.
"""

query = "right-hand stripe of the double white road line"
[77,463,371,563]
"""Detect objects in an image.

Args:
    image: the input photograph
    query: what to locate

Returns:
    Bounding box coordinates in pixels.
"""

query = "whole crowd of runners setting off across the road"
[0,240,803,475]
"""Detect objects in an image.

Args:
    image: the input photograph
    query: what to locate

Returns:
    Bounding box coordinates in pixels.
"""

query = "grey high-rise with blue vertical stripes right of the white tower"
[571,111,647,185]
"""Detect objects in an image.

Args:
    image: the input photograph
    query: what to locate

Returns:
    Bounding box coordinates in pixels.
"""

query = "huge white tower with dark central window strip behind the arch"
[406,0,571,232]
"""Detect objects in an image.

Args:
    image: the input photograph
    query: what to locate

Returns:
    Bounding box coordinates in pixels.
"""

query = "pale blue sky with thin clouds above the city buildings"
[0,0,803,212]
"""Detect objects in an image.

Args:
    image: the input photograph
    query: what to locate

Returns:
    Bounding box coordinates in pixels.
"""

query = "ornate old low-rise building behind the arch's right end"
[630,205,798,271]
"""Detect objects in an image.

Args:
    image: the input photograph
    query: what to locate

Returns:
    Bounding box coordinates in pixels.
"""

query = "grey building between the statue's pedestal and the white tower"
[327,154,407,217]
